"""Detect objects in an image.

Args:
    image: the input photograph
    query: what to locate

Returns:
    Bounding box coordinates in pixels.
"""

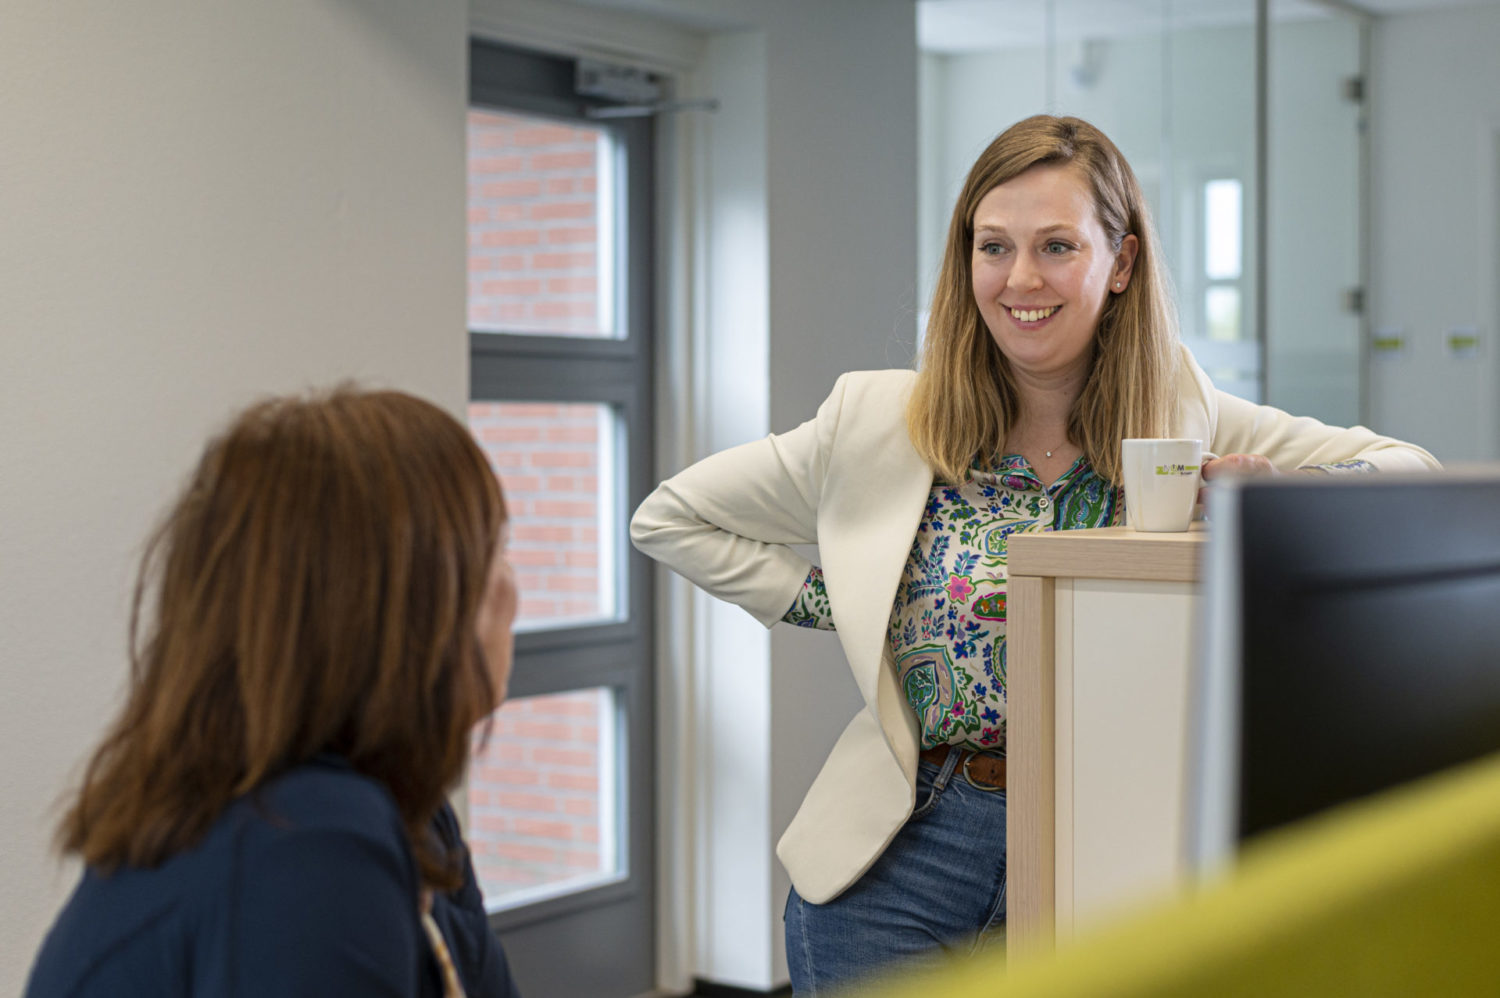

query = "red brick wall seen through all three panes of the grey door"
[468,111,618,900]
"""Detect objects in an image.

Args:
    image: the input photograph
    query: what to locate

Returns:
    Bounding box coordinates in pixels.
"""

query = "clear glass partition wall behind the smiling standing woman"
[918,0,1365,425]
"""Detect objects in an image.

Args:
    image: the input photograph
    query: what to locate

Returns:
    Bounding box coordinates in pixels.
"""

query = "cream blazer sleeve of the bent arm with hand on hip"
[630,375,849,627]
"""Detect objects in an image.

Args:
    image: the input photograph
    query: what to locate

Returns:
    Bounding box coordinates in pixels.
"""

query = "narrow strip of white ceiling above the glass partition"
[917,0,1500,53]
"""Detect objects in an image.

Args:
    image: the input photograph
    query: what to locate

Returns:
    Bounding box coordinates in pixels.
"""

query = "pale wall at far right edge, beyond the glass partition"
[1370,5,1500,461]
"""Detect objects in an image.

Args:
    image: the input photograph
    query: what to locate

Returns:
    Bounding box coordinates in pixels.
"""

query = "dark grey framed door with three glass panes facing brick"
[467,42,656,998]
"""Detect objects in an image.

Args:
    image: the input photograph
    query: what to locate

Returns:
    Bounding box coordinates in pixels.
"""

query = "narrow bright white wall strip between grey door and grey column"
[690,29,779,989]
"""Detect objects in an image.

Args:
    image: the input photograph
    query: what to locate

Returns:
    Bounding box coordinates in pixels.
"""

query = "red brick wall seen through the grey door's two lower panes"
[468,402,614,900]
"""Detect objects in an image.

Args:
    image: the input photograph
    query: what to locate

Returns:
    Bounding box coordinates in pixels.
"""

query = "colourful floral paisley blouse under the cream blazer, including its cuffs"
[782,455,1374,753]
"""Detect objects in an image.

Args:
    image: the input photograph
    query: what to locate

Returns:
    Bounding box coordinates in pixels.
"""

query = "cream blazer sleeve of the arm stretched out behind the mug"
[1185,352,1442,471]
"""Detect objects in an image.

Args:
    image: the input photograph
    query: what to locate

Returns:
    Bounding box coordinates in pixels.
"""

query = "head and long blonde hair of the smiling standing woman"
[909,116,1191,482]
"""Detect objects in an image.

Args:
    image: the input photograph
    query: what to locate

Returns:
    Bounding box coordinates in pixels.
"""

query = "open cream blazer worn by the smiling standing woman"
[630,350,1437,903]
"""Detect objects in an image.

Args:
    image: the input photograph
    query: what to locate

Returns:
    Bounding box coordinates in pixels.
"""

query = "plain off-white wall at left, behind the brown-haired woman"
[0,0,468,993]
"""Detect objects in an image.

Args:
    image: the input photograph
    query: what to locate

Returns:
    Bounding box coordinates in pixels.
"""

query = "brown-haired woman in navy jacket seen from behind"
[27,390,516,998]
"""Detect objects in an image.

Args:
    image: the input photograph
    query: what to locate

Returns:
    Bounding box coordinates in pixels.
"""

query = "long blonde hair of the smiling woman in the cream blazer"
[906,114,1179,485]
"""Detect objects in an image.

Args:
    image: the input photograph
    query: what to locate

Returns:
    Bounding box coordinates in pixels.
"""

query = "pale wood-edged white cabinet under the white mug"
[1007,524,1206,951]
